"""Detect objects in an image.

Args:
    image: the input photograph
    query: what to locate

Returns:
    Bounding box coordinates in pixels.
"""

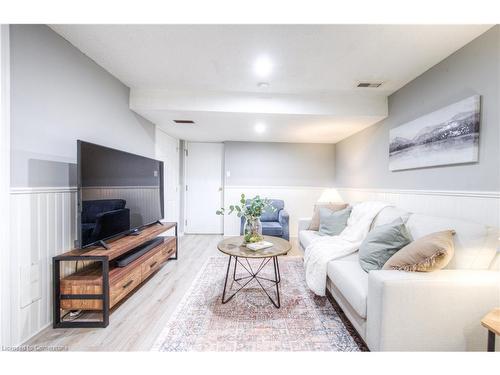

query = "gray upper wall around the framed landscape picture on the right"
[335,26,500,191]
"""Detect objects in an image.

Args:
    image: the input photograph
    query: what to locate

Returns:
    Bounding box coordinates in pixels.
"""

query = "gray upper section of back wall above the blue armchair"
[224,142,335,186]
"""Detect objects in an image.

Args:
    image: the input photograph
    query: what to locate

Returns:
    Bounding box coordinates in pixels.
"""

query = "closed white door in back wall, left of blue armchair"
[184,142,224,234]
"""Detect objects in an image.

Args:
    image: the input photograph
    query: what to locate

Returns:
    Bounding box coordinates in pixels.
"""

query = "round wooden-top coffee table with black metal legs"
[217,236,292,308]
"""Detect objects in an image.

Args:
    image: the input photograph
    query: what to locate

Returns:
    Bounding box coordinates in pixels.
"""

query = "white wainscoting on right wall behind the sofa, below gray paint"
[336,188,500,228]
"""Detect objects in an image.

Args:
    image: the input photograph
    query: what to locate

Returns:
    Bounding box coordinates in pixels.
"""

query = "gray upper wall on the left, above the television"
[10,25,155,187]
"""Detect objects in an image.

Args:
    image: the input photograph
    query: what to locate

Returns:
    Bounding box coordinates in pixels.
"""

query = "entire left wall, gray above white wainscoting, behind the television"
[7,25,179,345]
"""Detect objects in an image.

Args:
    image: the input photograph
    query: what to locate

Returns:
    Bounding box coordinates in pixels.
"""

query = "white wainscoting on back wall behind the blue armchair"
[224,185,327,237]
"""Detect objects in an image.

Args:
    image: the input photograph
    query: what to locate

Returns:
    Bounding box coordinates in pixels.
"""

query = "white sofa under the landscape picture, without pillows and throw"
[299,207,500,351]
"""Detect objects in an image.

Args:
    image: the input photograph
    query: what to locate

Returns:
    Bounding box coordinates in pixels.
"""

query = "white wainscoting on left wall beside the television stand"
[11,188,77,345]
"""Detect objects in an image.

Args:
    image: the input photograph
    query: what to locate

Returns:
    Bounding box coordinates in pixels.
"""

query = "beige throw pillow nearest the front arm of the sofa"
[382,230,455,272]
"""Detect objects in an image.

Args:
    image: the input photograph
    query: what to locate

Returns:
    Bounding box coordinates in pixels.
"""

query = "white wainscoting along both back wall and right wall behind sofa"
[224,185,500,237]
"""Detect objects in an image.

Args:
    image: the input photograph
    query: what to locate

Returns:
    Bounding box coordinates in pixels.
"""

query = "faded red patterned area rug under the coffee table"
[153,257,365,351]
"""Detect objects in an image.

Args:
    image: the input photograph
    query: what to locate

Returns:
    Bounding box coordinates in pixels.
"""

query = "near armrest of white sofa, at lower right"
[366,270,500,351]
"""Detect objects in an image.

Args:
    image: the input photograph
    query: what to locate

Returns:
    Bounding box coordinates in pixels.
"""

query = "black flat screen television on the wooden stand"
[77,140,164,248]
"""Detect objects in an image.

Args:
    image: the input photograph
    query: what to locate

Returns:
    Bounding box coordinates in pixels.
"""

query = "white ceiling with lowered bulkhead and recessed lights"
[51,25,489,143]
